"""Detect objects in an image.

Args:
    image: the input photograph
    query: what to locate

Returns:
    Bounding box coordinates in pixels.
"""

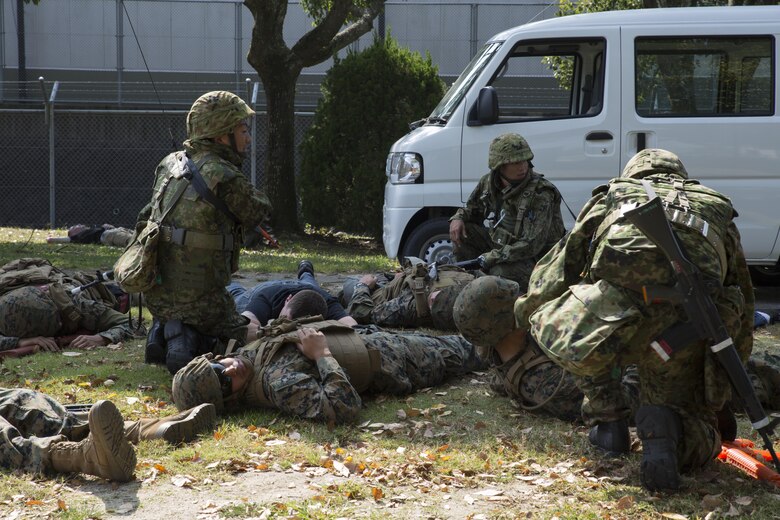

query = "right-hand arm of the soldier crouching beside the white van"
[485,189,561,267]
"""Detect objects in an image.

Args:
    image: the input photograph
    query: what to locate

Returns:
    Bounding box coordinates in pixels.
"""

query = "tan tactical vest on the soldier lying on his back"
[240,316,380,406]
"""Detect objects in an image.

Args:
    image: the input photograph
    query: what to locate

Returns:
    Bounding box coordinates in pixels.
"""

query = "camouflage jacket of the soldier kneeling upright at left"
[136,140,271,300]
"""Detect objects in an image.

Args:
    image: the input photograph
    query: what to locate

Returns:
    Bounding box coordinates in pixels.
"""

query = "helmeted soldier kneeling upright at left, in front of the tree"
[136,91,271,373]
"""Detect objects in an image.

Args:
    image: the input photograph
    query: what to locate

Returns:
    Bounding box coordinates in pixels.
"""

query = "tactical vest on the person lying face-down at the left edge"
[0,258,117,308]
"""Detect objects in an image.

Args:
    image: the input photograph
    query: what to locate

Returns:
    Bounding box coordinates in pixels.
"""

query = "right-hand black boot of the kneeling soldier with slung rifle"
[636,405,682,491]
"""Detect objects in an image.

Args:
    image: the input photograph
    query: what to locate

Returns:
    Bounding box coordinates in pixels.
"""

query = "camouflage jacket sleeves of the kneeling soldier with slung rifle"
[515,176,755,360]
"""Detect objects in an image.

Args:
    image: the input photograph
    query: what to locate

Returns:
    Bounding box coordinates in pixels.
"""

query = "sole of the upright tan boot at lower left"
[89,401,136,482]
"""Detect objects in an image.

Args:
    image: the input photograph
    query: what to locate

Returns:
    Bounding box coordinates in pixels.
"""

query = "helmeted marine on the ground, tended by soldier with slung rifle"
[453,276,638,422]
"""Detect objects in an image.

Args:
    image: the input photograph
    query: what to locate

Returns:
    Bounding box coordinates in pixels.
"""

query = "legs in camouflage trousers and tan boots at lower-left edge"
[0,388,216,482]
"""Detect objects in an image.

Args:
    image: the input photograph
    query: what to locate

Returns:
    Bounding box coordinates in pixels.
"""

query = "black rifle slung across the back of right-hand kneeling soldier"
[625,197,780,471]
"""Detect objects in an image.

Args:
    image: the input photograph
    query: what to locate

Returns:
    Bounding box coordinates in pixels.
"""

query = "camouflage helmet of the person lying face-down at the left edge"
[0,287,62,338]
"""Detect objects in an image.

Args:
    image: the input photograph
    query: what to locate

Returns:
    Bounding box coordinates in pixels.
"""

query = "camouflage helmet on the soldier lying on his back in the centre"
[172,356,224,412]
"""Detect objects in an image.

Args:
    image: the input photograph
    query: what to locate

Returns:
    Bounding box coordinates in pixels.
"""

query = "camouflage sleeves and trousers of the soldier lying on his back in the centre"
[234,326,484,423]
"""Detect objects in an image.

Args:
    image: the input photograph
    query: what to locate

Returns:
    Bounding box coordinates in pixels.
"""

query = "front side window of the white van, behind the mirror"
[489,38,606,123]
